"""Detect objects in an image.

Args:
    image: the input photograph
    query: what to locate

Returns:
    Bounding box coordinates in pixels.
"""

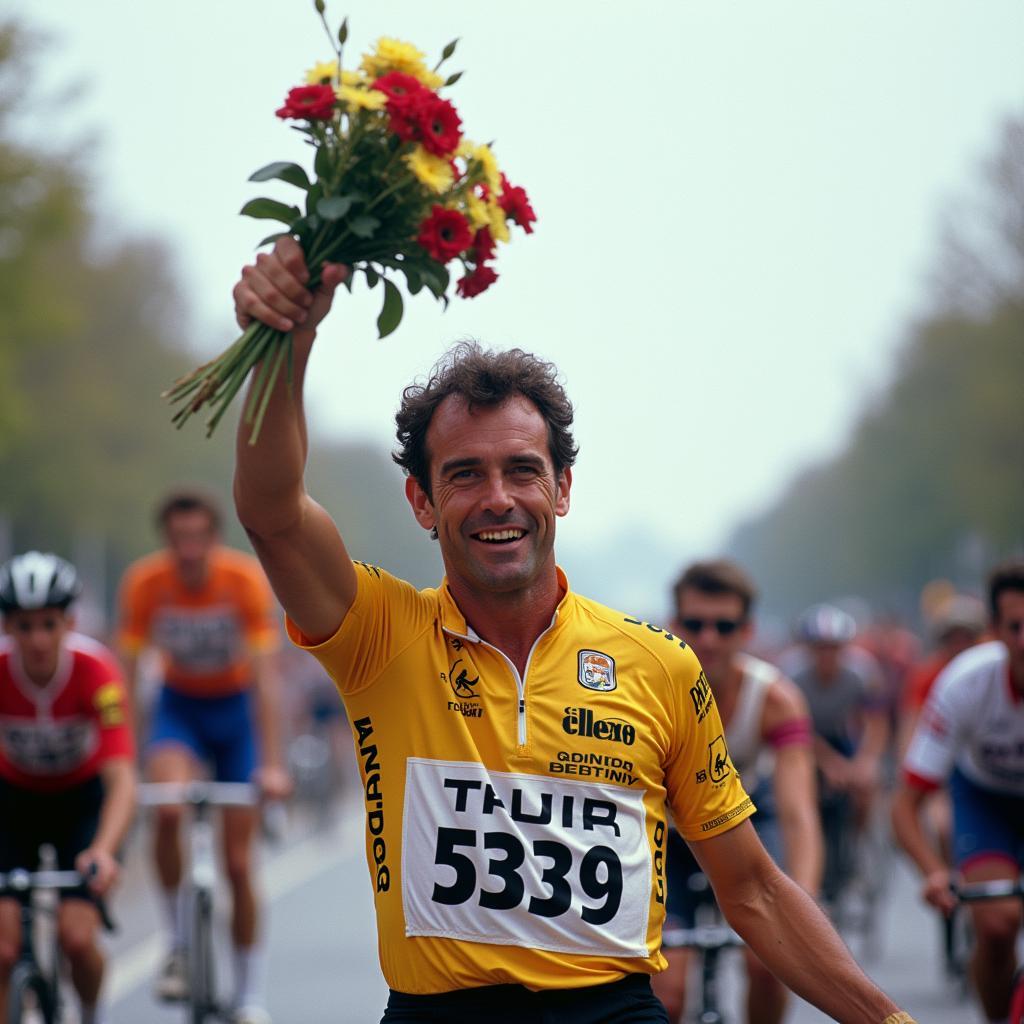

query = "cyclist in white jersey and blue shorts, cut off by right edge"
[893,560,1024,1021]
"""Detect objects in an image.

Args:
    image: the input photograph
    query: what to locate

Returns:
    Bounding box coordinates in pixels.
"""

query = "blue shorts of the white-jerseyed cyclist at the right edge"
[949,770,1024,870]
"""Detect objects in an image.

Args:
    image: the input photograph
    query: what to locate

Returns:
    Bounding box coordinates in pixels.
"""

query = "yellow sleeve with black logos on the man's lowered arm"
[666,649,755,840]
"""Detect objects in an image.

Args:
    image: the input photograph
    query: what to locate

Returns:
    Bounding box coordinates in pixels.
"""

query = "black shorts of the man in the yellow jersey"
[381,974,669,1024]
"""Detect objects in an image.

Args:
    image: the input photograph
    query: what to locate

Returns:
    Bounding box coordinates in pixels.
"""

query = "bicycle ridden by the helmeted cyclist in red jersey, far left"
[0,847,114,1024]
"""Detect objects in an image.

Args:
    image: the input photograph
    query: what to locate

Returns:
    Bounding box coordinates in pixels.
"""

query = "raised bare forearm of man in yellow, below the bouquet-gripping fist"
[234,332,314,535]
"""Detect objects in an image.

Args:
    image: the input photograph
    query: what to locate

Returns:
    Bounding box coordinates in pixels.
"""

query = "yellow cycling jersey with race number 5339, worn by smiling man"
[289,562,754,994]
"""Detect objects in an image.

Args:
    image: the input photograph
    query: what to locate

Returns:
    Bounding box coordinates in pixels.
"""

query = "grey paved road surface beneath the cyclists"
[101,795,981,1024]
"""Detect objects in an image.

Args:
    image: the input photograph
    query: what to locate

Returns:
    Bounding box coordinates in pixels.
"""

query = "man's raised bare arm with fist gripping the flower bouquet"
[234,238,355,642]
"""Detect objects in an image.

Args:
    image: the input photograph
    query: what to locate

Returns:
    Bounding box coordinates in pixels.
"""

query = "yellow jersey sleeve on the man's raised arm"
[285,562,437,693]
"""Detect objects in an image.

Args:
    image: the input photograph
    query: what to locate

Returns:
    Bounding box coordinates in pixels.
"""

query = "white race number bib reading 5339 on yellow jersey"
[401,758,651,957]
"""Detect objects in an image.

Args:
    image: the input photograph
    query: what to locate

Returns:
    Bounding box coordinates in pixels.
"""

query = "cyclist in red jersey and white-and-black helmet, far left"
[0,551,135,1024]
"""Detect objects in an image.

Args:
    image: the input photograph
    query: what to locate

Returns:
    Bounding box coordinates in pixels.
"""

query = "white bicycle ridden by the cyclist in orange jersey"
[139,781,259,1024]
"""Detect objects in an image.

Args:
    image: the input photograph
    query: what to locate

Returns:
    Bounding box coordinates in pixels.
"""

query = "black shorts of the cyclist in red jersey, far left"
[0,775,103,902]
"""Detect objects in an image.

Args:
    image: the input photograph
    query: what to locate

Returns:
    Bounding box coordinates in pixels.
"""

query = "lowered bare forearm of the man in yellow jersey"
[720,872,899,1024]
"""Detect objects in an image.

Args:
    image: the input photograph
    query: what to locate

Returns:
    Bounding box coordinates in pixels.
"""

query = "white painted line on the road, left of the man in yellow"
[104,815,362,1006]
